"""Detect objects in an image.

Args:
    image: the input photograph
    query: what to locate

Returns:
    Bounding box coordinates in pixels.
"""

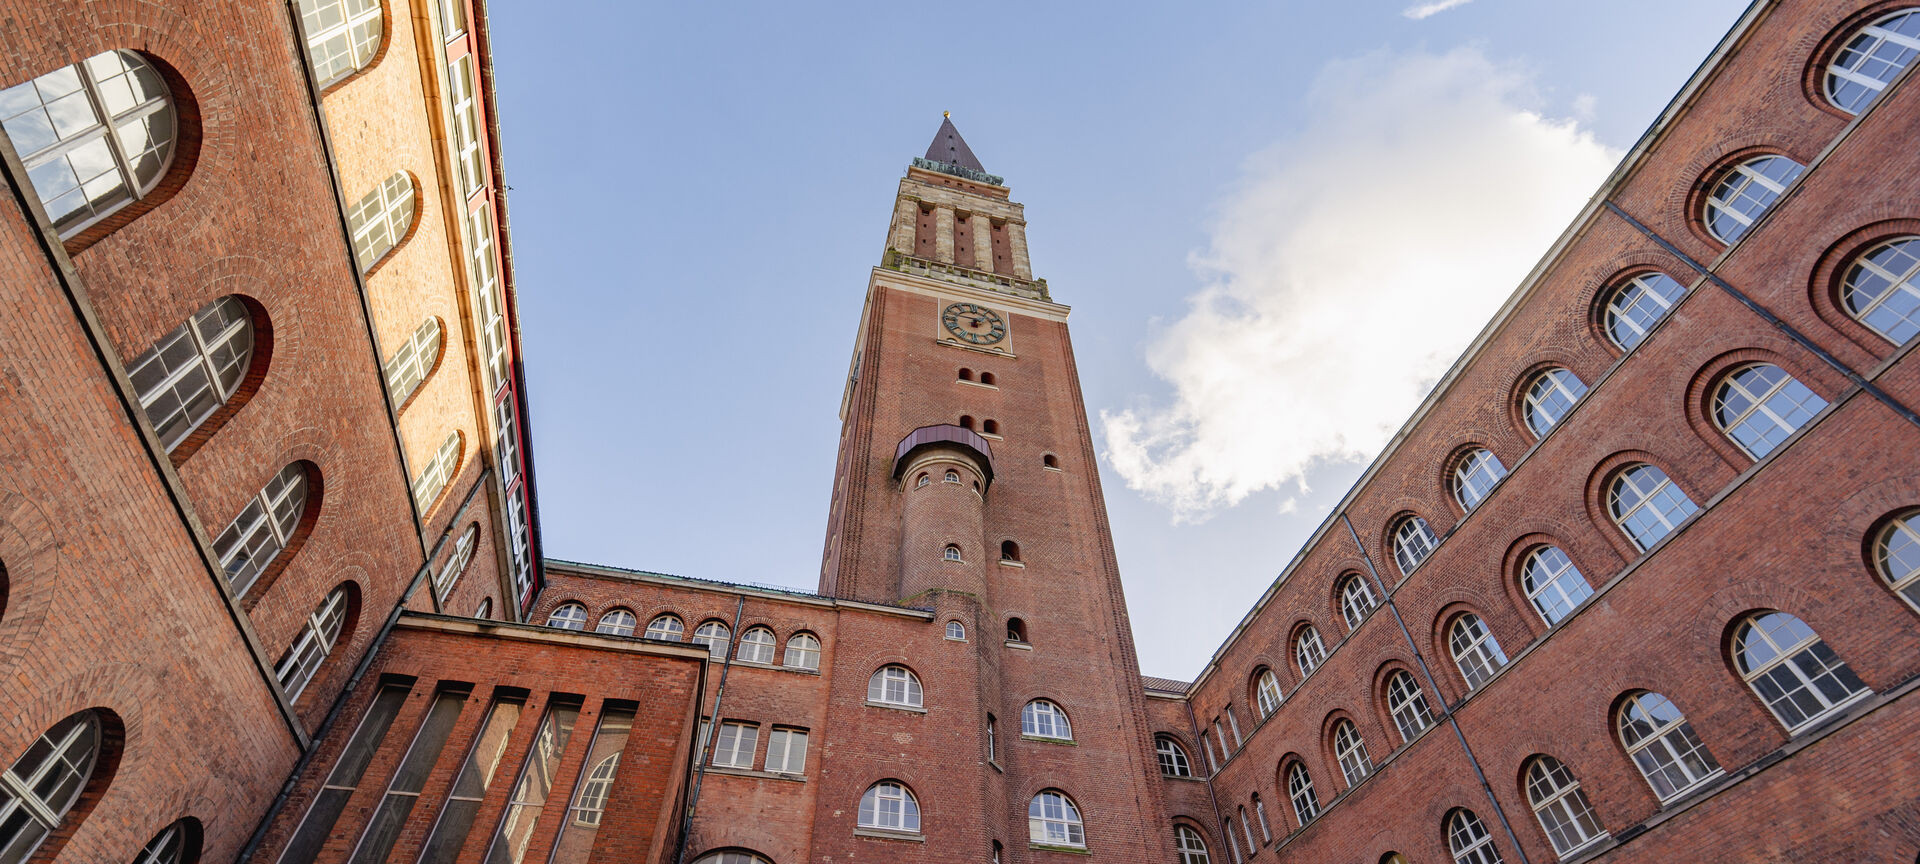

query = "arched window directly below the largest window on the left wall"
[127,294,253,451]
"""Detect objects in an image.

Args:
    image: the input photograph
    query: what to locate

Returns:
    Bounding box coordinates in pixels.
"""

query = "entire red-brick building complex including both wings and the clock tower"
[0,0,1920,864]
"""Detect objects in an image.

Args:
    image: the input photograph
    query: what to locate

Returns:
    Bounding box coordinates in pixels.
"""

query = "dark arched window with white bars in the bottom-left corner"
[0,710,102,864]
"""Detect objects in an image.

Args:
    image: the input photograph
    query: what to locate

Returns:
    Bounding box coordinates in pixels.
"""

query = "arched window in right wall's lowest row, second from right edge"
[1734,612,1872,732]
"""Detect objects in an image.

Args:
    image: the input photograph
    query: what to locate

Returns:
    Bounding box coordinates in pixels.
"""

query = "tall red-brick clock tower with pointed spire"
[820,119,1171,862]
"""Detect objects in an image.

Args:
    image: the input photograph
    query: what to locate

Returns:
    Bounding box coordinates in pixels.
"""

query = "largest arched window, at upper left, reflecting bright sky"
[0,52,179,238]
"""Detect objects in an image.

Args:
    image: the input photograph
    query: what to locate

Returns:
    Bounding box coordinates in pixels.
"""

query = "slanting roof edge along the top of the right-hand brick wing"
[1187,0,1780,697]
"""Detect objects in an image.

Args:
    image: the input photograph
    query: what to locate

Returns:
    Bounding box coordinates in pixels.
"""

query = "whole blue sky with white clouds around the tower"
[492,0,1745,678]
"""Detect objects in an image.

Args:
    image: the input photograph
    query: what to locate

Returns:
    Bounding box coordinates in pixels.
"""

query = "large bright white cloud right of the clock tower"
[1100,48,1620,520]
